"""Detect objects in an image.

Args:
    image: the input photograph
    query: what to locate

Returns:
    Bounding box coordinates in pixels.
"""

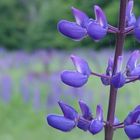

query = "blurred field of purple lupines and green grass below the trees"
[0,49,140,140]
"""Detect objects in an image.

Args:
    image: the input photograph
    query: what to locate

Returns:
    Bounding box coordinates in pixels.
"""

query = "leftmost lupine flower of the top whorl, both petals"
[58,7,89,41]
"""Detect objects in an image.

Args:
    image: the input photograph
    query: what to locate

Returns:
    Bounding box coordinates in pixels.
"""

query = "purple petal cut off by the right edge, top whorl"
[134,17,140,41]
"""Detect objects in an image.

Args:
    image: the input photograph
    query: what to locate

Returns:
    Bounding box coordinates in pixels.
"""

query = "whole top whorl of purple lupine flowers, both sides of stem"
[58,0,140,41]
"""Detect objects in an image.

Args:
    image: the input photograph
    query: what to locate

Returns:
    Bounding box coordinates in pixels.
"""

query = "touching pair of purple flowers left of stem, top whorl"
[58,5,108,41]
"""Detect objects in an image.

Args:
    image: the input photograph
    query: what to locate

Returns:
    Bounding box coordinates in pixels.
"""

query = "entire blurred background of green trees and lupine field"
[0,0,140,140]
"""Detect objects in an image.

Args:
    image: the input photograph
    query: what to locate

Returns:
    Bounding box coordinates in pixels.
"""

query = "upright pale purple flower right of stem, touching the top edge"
[126,0,136,27]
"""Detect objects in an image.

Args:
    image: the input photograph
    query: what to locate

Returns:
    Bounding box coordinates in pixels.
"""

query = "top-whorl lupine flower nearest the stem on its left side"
[87,5,108,41]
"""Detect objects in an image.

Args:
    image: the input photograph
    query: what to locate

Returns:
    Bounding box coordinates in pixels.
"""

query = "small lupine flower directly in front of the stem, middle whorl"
[111,56,126,88]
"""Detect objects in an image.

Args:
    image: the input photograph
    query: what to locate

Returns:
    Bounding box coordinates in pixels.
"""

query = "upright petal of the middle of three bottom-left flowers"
[79,101,92,120]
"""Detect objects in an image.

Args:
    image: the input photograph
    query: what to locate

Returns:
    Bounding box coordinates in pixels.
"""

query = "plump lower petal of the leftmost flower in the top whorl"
[58,20,87,41]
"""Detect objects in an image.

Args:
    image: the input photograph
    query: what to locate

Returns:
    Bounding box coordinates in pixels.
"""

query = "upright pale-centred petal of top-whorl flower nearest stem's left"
[94,5,108,29]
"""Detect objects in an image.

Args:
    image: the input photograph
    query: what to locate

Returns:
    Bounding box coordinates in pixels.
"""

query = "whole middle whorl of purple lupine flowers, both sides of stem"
[61,50,140,88]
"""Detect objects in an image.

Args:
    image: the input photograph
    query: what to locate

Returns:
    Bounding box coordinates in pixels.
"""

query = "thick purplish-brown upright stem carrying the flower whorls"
[105,0,128,140]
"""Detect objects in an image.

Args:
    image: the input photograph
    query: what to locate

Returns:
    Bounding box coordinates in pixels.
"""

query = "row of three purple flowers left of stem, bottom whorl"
[47,101,103,134]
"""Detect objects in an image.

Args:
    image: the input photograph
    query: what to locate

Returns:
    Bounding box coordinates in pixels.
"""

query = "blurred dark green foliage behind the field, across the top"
[0,0,140,50]
